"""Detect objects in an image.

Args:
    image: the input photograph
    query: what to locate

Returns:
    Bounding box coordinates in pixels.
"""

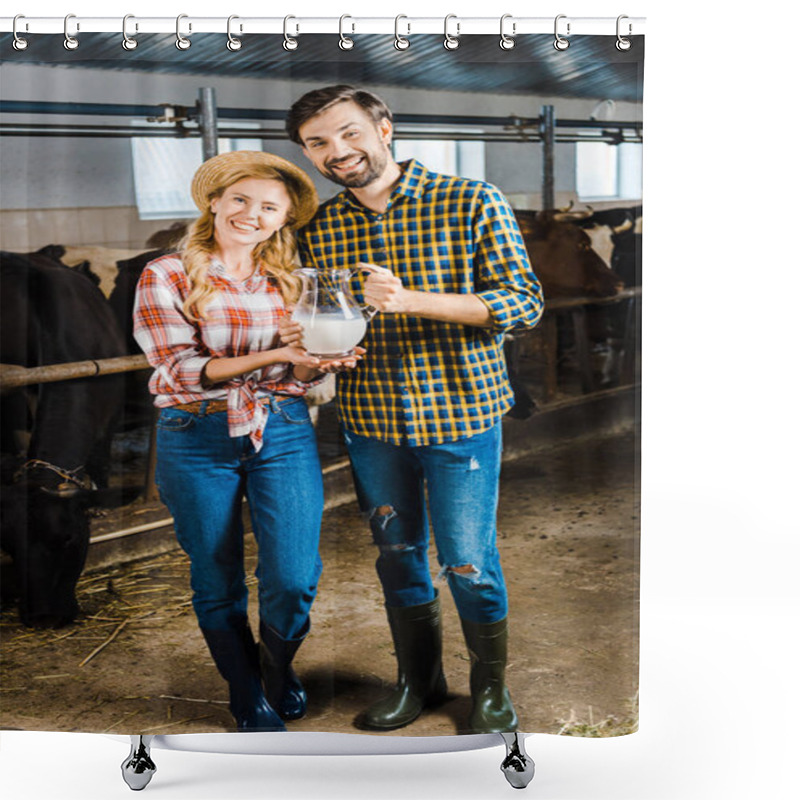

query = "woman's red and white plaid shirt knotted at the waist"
[133,255,321,451]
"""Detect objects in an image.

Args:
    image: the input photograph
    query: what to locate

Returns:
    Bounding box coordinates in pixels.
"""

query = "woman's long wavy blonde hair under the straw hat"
[178,166,301,322]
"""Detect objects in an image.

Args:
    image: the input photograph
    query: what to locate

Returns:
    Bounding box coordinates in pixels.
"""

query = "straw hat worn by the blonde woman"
[192,150,319,228]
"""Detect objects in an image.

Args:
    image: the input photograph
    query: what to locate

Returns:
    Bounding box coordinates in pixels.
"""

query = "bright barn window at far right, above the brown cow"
[575,142,642,200]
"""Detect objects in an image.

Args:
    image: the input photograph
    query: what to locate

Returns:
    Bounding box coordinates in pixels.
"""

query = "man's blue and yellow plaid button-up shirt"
[299,159,543,446]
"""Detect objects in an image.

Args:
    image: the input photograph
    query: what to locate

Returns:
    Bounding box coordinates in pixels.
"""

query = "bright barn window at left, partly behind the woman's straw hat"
[131,126,261,219]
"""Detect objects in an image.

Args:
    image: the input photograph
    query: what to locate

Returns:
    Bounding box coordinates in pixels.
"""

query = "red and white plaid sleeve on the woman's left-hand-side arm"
[133,266,211,394]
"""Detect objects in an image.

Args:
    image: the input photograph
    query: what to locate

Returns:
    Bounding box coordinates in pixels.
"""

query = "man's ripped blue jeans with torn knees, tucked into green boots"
[344,423,508,623]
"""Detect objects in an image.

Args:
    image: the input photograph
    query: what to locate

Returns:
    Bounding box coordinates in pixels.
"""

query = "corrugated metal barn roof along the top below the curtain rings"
[0,33,644,102]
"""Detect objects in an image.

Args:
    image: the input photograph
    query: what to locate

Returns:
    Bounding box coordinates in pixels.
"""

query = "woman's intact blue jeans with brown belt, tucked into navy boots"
[156,397,322,639]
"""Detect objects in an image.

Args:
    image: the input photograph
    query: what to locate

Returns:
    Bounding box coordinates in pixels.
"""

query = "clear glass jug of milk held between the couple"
[292,267,376,359]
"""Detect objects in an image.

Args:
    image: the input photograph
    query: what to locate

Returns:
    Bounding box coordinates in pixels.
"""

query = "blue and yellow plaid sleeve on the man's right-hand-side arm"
[473,185,544,333]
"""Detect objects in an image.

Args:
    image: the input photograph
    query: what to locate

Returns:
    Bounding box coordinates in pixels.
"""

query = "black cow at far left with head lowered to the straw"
[0,253,126,626]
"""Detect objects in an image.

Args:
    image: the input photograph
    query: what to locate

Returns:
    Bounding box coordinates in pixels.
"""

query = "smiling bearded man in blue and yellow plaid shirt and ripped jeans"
[283,86,543,733]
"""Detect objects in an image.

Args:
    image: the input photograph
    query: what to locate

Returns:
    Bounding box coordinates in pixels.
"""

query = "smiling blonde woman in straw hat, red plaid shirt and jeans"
[134,151,364,731]
